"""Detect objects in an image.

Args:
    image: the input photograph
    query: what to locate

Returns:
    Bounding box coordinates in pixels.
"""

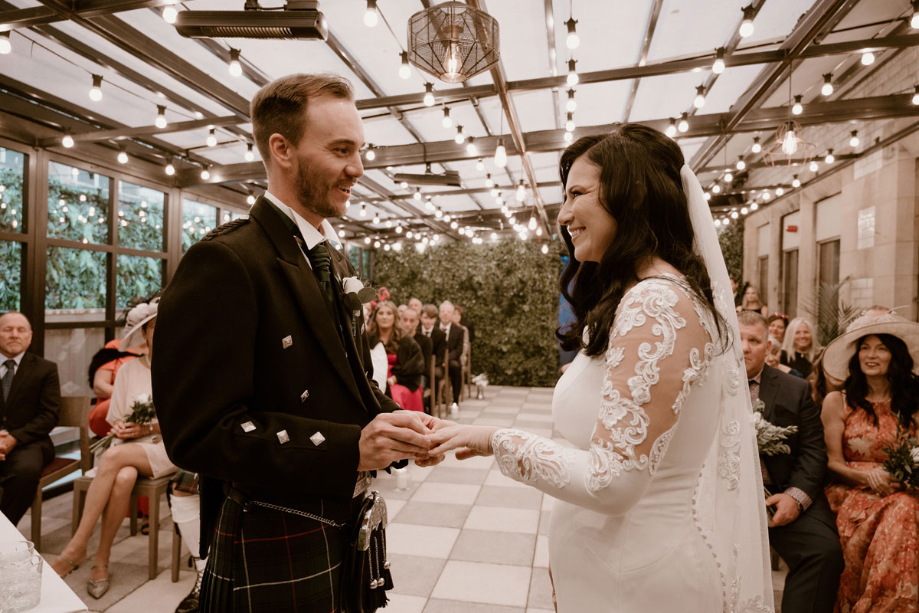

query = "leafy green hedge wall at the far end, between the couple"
[373,239,561,386]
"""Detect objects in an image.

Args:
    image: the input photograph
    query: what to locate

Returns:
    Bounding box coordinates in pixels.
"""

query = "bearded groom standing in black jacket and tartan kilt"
[153,74,436,612]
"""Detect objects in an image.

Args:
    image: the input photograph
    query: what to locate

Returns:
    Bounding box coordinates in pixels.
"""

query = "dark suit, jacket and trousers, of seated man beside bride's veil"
[759,366,843,613]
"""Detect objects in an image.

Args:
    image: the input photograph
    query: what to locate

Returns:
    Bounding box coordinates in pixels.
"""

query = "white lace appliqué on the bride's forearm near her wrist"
[491,430,574,489]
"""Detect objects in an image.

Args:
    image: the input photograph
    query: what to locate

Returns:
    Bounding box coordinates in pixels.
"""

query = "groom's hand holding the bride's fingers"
[357,411,431,470]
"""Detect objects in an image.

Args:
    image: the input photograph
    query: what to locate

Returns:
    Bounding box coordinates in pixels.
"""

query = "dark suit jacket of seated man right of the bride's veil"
[759,366,836,528]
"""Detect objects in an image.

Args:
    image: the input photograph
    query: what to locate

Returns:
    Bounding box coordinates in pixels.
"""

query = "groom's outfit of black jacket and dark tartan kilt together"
[153,197,399,613]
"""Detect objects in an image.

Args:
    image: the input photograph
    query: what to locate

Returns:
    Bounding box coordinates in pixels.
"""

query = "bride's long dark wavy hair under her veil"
[556,124,725,356]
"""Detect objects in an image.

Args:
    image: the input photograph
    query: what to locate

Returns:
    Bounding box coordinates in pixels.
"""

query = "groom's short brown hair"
[249,73,354,164]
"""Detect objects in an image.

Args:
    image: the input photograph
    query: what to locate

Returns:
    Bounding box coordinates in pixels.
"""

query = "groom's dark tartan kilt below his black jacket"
[199,486,363,613]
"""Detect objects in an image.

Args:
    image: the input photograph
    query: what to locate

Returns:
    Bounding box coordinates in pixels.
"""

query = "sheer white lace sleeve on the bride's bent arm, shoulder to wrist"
[492,280,713,515]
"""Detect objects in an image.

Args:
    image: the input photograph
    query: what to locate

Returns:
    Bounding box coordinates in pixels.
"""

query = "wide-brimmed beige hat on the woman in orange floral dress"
[823,313,919,380]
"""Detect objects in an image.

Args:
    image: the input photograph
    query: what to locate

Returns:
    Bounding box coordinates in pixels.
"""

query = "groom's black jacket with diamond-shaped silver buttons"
[153,198,399,557]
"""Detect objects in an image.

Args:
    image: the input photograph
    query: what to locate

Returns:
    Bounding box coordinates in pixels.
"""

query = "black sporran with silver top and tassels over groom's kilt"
[340,491,393,613]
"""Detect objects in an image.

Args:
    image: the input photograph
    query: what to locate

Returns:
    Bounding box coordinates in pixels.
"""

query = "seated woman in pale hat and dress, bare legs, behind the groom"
[51,299,176,598]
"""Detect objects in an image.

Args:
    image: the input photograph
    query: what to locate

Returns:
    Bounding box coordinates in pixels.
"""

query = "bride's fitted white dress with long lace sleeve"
[493,275,736,613]
